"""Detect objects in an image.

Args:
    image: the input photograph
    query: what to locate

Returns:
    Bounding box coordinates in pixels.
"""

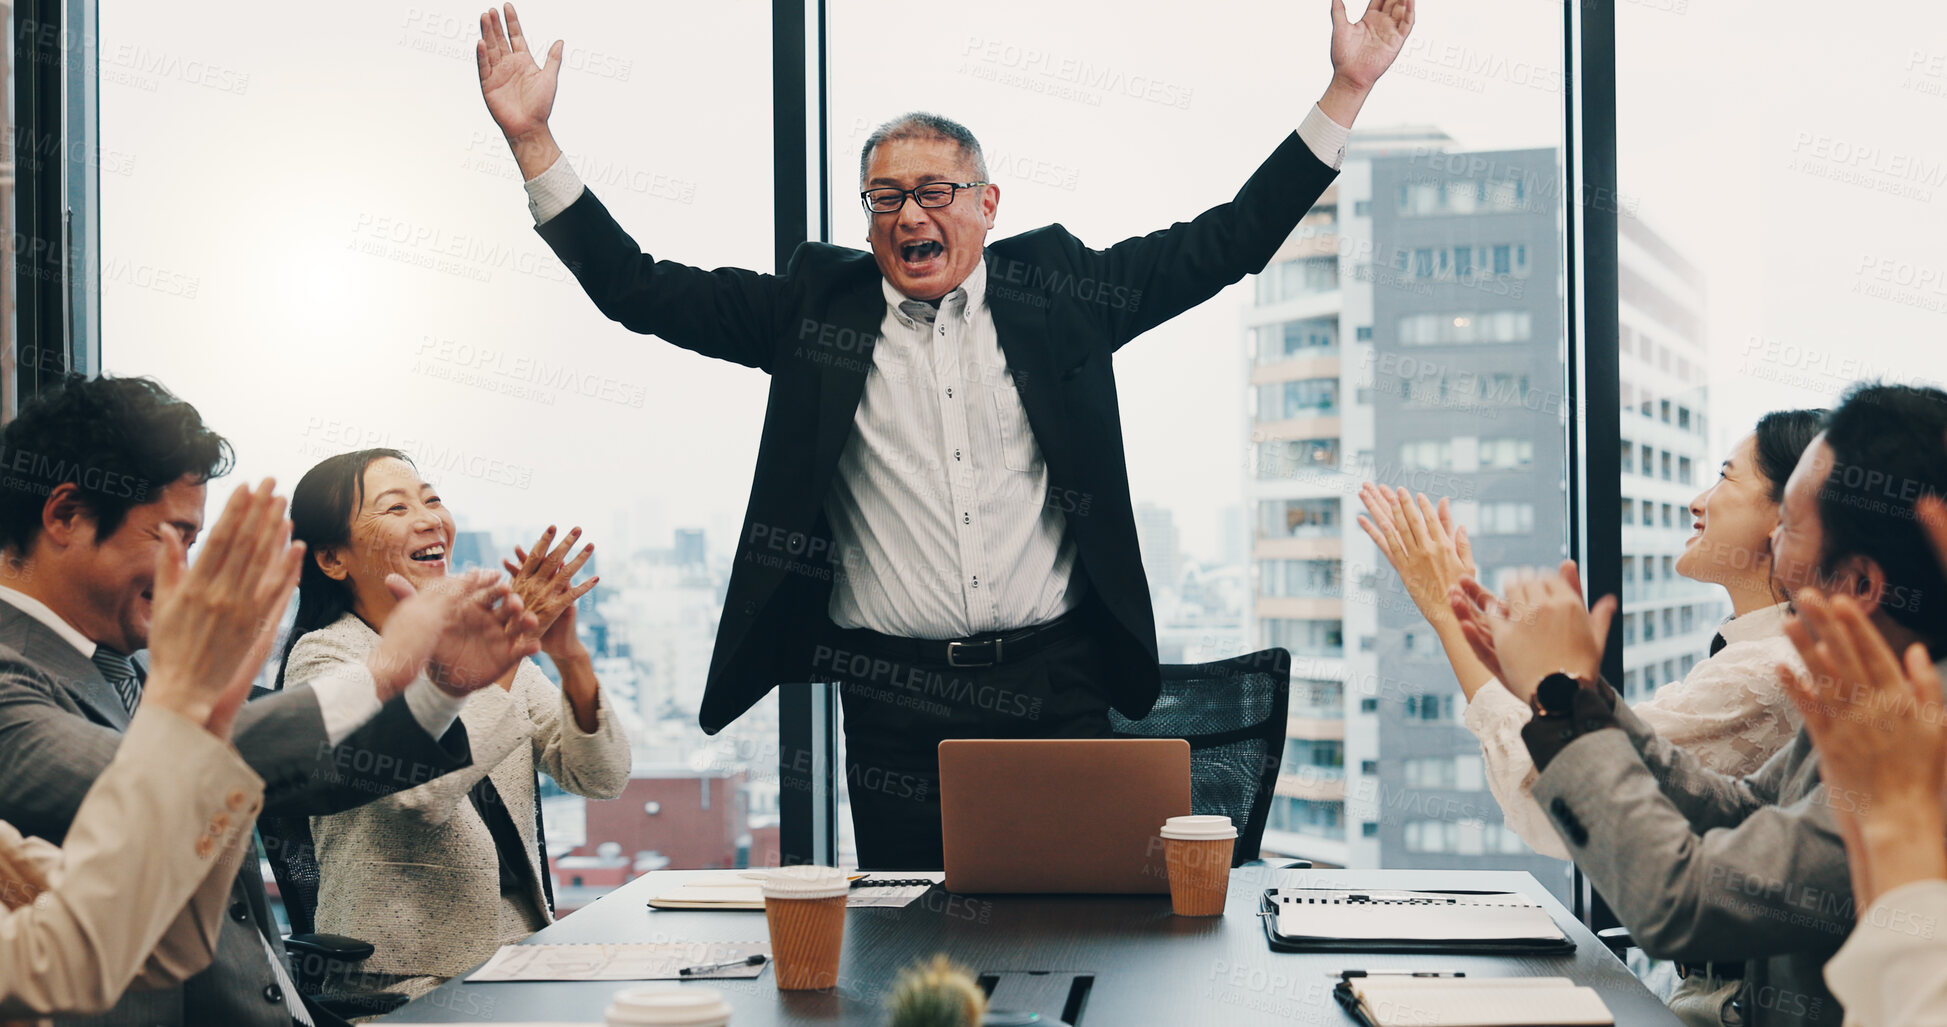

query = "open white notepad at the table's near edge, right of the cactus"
[1334,976,1616,1027]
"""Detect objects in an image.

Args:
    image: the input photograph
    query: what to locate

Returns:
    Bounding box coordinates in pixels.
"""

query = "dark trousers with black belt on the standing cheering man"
[829,631,1110,869]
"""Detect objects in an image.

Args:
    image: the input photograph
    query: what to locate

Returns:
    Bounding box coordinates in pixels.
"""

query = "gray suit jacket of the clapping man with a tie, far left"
[0,602,471,1027]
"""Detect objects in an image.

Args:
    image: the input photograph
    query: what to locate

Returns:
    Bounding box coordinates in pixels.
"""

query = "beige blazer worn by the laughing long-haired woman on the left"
[286,614,629,976]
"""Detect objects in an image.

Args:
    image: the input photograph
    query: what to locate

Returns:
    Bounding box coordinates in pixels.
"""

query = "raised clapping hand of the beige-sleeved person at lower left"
[142,477,304,739]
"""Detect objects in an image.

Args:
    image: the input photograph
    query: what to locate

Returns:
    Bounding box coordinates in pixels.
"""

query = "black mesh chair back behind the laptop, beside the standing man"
[1108,649,1291,865]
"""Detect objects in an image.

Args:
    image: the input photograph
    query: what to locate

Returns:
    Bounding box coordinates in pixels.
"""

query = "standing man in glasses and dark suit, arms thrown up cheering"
[477,0,1414,867]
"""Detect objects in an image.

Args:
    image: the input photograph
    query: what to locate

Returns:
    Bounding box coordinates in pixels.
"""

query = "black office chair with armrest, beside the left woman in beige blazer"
[257,813,409,1019]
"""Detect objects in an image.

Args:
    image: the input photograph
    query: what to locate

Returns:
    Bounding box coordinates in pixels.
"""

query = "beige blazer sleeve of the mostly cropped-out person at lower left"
[0,704,263,1019]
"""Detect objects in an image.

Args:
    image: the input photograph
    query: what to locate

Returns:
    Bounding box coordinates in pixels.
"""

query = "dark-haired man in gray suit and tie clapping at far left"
[0,378,533,1027]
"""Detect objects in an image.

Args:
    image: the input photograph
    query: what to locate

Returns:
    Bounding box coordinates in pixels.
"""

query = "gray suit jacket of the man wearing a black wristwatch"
[1534,678,1854,1027]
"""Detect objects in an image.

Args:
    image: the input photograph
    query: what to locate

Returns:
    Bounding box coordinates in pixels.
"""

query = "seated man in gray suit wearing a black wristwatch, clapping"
[1456,384,1947,1027]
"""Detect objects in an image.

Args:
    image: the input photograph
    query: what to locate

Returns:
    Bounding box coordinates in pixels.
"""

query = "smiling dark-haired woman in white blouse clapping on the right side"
[1359,409,1824,859]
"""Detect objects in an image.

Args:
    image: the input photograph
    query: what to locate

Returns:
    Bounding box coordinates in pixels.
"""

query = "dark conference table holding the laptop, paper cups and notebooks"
[384,867,1678,1027]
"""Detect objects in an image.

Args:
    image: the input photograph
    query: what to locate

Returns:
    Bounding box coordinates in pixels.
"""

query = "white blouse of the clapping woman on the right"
[1462,602,1805,859]
